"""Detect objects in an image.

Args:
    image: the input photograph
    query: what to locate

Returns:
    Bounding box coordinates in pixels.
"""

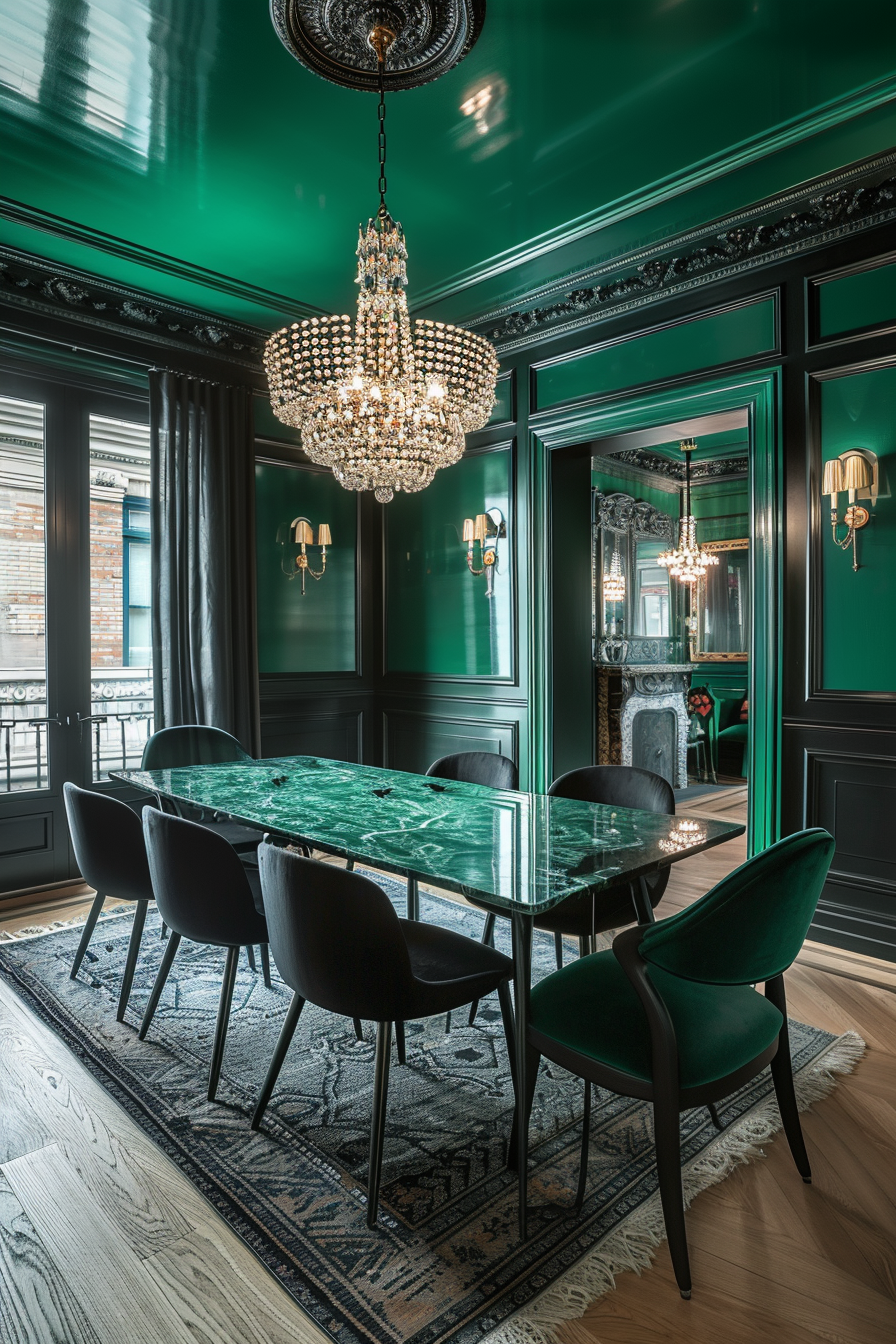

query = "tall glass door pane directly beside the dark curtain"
[90,415,153,780]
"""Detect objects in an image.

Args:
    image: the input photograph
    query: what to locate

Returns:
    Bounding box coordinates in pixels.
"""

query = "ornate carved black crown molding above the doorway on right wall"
[480,153,896,353]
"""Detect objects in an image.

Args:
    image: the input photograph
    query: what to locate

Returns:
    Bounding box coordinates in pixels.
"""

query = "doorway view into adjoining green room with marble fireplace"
[590,409,752,821]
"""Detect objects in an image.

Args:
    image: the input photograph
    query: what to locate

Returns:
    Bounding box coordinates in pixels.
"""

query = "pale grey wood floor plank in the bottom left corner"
[0,1172,99,1344]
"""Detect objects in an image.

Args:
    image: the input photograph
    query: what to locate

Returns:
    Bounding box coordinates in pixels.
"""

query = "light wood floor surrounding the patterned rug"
[0,790,896,1344]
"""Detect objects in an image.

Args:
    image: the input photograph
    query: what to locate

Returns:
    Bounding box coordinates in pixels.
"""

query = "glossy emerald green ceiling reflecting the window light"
[0,0,896,325]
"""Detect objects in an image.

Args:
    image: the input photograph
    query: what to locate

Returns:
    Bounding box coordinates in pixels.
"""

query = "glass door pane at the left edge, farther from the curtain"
[0,396,48,793]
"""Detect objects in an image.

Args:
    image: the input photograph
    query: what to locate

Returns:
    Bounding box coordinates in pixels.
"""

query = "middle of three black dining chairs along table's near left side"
[140,808,267,1101]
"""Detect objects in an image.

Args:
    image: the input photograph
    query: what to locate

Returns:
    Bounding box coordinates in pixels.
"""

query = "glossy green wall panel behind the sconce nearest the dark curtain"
[255,462,357,673]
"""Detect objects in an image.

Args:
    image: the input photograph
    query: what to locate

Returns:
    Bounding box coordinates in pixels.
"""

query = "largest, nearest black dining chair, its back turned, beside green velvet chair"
[251,844,514,1227]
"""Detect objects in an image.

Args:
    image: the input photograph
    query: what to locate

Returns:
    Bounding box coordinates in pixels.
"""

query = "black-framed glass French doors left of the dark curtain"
[0,368,152,896]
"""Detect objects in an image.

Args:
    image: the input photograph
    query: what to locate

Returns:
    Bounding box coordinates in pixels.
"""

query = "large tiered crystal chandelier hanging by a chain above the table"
[265,27,498,504]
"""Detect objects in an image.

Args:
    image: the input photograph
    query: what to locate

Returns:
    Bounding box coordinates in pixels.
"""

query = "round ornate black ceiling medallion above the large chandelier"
[270,0,485,90]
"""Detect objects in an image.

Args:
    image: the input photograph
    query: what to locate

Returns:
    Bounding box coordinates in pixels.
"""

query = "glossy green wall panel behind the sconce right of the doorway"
[818,367,896,691]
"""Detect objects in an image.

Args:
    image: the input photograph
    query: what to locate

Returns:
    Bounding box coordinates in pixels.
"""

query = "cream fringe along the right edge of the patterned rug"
[482,1031,865,1344]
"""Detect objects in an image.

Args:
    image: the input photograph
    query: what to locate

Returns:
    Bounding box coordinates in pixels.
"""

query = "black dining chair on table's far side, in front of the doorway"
[467,765,676,1027]
